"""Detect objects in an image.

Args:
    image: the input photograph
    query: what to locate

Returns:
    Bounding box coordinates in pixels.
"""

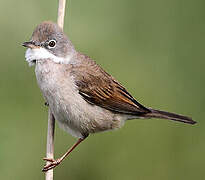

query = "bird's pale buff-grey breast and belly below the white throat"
[35,60,124,137]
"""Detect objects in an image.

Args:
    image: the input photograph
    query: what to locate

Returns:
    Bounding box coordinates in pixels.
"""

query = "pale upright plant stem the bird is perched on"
[45,0,66,180]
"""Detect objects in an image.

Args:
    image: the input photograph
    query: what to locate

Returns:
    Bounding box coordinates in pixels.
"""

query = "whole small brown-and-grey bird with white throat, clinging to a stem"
[23,21,196,171]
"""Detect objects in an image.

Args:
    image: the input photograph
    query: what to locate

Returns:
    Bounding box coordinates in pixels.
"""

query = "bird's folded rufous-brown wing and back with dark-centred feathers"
[72,53,150,115]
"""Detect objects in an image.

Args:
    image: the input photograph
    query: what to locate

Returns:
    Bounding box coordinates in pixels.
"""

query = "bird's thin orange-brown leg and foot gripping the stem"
[42,136,87,172]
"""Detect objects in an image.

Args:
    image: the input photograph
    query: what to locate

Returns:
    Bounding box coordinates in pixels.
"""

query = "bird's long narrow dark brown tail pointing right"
[144,108,196,124]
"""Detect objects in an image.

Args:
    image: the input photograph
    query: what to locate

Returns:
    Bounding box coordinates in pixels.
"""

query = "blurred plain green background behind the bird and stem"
[0,0,205,180]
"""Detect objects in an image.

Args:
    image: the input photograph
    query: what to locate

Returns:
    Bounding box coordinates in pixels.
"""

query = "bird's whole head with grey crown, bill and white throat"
[22,21,75,63]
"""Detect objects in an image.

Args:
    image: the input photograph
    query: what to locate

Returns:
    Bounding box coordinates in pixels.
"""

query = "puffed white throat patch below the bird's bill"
[25,47,72,66]
